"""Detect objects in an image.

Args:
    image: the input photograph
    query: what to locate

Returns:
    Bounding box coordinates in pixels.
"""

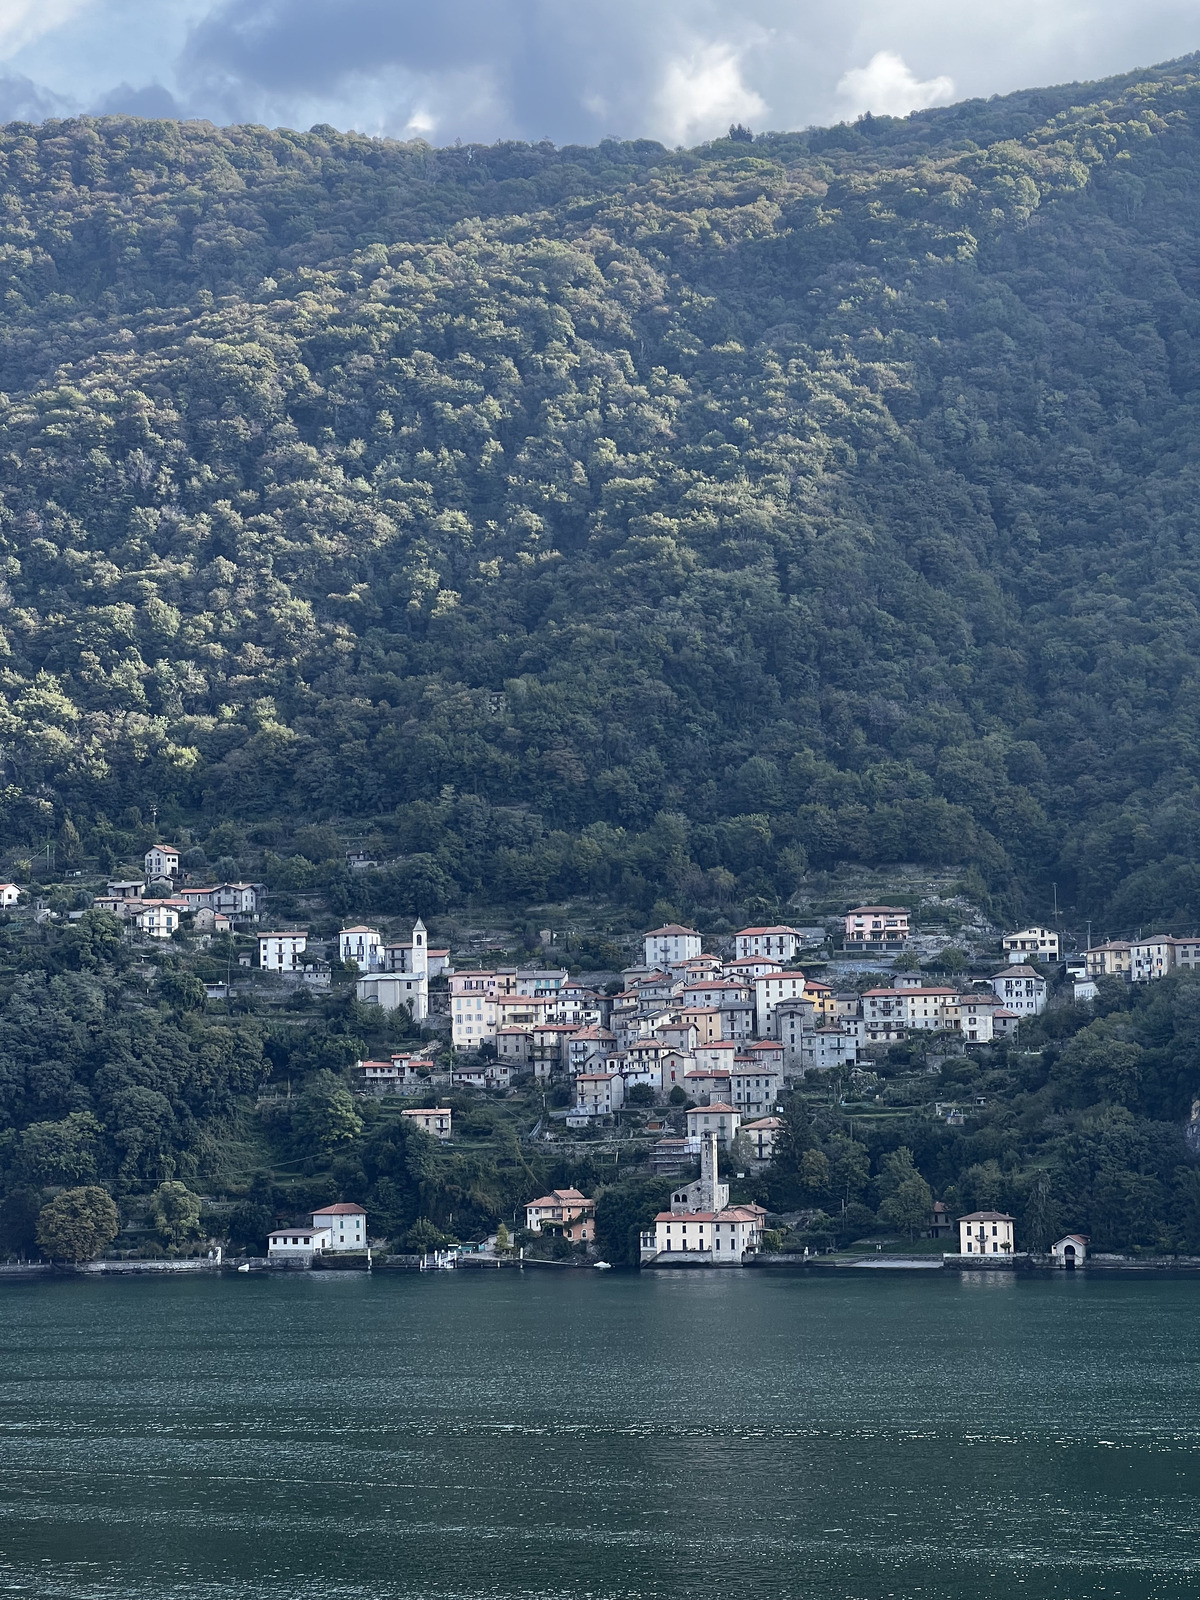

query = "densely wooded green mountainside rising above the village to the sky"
[0,58,1200,933]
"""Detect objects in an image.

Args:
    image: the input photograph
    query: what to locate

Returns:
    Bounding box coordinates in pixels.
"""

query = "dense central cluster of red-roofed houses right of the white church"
[435,928,1048,1158]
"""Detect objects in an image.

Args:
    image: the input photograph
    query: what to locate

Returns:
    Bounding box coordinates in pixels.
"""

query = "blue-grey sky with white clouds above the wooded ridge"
[0,0,1200,144]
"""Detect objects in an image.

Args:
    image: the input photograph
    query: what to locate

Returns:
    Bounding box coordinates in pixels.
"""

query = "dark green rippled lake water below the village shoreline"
[0,1272,1200,1600]
